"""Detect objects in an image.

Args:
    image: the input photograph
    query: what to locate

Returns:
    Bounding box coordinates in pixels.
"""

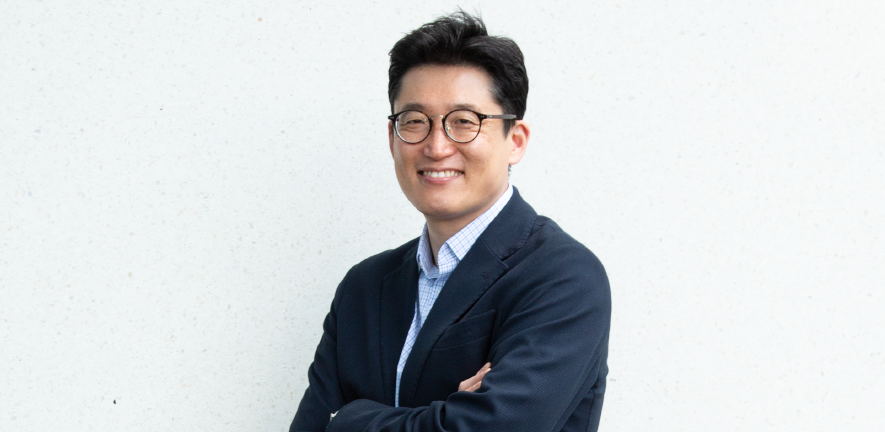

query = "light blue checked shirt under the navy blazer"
[395,185,513,406]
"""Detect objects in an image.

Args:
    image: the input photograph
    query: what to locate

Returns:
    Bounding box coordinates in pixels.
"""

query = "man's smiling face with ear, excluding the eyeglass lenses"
[388,65,529,224]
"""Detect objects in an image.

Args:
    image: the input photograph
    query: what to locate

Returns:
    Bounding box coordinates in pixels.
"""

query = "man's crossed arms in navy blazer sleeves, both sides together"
[291,246,610,432]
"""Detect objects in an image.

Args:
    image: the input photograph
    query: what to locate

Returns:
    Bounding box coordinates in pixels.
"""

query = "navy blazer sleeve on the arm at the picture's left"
[289,273,350,432]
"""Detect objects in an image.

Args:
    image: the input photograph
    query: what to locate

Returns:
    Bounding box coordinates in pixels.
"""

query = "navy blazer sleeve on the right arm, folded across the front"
[326,244,611,432]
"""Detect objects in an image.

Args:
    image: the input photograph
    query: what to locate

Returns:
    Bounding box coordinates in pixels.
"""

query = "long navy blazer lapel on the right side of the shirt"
[394,188,537,407]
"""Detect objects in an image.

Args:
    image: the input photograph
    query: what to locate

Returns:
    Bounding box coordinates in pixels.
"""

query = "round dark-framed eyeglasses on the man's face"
[387,109,516,144]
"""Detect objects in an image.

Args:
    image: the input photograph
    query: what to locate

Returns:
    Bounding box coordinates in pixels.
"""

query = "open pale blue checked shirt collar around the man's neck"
[416,183,513,278]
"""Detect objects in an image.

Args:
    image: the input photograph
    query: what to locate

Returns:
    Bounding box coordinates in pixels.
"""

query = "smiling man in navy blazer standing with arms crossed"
[290,12,611,432]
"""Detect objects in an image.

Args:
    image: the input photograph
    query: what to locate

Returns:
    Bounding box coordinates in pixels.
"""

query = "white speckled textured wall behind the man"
[0,0,885,432]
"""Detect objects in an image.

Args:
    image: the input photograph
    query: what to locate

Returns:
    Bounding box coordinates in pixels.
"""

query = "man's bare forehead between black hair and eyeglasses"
[394,65,498,115]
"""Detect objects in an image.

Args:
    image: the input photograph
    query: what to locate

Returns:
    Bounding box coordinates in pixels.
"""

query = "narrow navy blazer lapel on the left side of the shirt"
[379,242,418,406]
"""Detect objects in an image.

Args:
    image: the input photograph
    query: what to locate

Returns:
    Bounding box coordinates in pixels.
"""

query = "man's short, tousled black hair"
[387,10,529,134]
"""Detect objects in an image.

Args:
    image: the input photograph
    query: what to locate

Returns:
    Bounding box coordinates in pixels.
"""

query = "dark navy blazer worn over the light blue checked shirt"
[290,189,611,432]
